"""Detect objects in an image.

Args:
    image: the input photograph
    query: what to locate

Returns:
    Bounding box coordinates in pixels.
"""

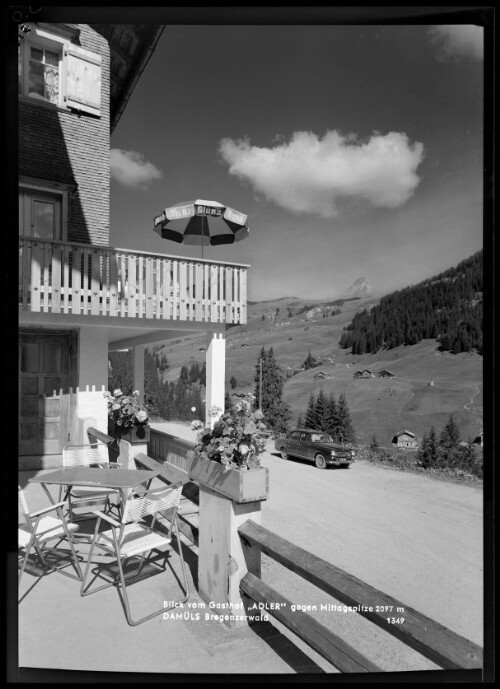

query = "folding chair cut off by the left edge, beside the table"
[18,486,82,583]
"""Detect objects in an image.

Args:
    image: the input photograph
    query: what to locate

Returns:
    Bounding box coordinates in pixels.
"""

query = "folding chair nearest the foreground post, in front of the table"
[80,483,189,626]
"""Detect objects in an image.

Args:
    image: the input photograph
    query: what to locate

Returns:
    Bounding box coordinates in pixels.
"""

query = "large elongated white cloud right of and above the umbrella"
[219,131,424,218]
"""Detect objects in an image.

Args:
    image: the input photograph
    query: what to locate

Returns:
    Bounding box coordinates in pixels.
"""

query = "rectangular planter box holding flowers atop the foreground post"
[189,455,269,503]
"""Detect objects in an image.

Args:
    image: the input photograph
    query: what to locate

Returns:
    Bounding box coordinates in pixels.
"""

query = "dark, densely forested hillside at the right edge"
[339,250,483,354]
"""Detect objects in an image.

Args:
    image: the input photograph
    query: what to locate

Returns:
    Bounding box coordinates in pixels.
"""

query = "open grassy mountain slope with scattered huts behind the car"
[155,297,483,445]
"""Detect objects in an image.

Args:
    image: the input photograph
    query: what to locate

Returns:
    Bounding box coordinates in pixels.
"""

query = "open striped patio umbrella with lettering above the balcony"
[153,199,249,256]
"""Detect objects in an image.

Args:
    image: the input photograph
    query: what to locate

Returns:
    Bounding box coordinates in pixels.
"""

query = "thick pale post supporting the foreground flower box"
[198,485,261,628]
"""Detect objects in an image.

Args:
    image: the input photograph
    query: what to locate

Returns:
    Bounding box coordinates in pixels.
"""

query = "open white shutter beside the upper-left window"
[64,44,101,115]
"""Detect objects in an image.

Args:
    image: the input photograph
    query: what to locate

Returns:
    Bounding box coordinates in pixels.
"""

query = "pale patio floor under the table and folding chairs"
[18,460,337,675]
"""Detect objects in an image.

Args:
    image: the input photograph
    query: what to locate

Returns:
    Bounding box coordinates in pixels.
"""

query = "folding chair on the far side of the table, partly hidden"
[59,443,120,521]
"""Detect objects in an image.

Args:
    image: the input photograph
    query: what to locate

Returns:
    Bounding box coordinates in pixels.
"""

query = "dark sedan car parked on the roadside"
[276,428,352,469]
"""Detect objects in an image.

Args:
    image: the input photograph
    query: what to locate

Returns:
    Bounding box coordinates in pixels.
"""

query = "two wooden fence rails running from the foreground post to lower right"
[238,520,483,671]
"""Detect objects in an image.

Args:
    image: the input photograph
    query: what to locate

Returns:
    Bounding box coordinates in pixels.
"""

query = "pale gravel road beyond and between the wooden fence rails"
[262,445,483,671]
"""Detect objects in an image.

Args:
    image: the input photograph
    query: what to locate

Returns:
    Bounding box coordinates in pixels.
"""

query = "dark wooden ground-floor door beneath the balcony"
[19,332,70,456]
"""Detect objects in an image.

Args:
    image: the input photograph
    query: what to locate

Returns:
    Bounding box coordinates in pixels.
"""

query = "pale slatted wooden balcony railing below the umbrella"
[19,237,248,323]
